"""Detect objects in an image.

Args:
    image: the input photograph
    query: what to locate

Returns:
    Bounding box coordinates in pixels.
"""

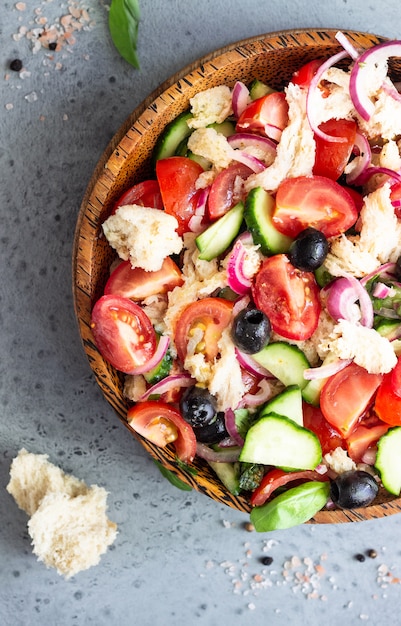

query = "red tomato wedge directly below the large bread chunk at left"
[104,257,183,300]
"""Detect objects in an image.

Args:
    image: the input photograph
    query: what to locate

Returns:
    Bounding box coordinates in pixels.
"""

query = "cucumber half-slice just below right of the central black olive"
[252,341,310,389]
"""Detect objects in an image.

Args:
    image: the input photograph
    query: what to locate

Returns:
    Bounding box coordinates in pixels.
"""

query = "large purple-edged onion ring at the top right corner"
[349,41,401,121]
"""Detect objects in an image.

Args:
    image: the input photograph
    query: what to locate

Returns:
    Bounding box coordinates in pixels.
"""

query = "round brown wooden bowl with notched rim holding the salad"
[73,30,401,523]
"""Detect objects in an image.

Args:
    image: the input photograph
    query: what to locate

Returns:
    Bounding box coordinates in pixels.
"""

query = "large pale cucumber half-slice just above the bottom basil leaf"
[239,413,322,470]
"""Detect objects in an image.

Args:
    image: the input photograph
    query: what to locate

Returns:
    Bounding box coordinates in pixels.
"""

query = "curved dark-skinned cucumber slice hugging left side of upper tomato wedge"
[244,187,293,256]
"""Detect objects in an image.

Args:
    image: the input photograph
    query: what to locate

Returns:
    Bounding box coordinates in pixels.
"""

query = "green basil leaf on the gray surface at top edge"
[109,0,140,69]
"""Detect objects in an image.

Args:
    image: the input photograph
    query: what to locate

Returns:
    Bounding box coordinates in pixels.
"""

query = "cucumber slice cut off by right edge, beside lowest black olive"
[375,426,401,496]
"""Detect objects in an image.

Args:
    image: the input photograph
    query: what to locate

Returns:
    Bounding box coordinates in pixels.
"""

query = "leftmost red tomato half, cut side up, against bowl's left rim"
[91,295,156,374]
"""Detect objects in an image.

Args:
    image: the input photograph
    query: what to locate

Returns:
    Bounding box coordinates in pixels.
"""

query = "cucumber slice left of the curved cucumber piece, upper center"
[195,202,244,261]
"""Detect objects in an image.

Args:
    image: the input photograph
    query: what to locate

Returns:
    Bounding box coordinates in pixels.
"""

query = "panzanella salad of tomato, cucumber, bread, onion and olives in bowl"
[92,33,401,531]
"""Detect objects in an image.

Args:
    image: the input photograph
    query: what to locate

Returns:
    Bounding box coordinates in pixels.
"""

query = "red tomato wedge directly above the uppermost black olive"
[273,176,358,239]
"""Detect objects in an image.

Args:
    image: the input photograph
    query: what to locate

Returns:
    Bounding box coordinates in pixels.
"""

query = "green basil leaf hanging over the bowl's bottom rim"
[251,481,330,533]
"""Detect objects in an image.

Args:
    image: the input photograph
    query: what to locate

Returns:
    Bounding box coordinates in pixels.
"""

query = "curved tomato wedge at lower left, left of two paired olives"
[127,400,196,463]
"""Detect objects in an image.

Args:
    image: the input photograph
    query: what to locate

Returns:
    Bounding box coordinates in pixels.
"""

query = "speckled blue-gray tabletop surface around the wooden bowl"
[0,0,401,626]
